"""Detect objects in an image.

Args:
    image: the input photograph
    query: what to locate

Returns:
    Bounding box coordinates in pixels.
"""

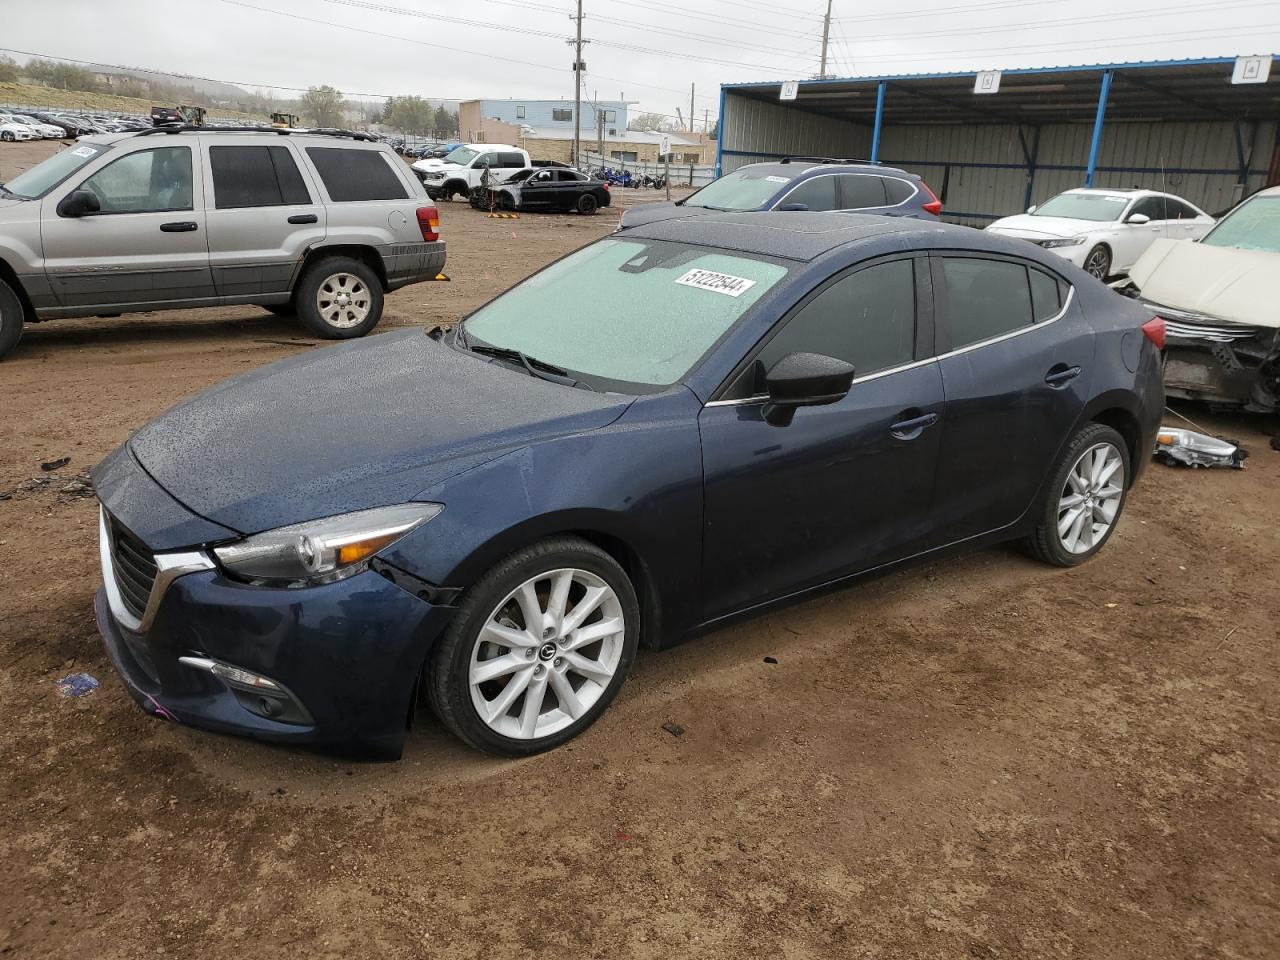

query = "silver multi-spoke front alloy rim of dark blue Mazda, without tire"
[467,568,626,740]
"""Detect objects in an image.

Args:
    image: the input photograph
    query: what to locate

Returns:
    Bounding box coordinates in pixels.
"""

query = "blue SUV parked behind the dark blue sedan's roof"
[618,156,942,230]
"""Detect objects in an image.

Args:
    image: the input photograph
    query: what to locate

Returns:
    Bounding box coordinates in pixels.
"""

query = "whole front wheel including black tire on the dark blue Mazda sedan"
[424,536,640,756]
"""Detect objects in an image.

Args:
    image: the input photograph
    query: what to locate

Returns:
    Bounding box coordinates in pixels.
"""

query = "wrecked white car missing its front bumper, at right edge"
[1115,187,1280,413]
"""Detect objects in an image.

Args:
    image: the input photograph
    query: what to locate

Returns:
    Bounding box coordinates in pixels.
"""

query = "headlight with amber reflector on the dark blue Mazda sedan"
[214,503,444,586]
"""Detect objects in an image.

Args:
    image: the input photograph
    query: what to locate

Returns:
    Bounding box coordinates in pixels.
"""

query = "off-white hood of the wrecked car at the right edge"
[1129,239,1280,329]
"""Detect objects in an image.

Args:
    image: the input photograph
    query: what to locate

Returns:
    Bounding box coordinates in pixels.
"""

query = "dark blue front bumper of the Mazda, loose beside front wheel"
[93,527,453,759]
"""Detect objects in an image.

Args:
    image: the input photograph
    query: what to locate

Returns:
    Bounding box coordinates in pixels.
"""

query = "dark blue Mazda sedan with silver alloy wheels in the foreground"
[93,214,1164,756]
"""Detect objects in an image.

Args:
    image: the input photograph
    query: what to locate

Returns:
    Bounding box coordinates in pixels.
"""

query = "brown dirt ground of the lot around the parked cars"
[0,145,1280,960]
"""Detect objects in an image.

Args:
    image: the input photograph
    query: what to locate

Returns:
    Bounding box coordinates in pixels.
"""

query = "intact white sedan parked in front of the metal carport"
[987,187,1215,279]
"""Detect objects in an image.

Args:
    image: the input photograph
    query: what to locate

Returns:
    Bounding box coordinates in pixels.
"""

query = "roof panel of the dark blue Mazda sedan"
[622,210,972,261]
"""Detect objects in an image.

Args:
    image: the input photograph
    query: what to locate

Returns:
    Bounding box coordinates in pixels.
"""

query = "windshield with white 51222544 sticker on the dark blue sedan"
[466,239,787,393]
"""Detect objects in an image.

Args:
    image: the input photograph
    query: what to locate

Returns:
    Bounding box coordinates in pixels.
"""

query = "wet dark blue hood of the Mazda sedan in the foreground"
[129,329,630,534]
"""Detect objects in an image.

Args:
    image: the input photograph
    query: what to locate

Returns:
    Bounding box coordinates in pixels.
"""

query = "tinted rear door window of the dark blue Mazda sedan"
[936,257,1039,349]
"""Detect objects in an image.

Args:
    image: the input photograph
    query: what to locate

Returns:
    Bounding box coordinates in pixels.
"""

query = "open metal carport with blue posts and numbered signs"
[716,58,1280,225]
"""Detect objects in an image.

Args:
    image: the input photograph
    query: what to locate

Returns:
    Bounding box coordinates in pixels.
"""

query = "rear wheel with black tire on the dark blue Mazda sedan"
[1025,424,1133,567]
